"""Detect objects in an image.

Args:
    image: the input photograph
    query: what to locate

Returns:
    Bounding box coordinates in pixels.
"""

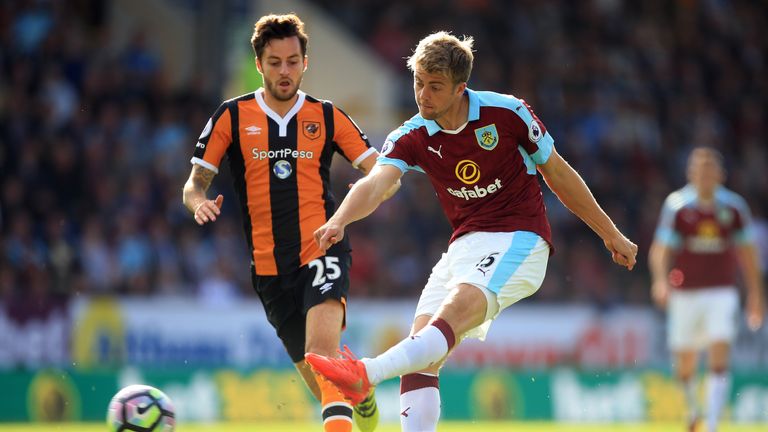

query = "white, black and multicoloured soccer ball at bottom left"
[107,385,176,432]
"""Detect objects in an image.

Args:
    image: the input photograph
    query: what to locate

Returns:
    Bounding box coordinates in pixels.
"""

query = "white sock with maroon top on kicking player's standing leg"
[400,374,440,432]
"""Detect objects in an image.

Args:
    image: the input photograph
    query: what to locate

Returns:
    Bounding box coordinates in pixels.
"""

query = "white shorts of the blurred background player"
[667,286,739,352]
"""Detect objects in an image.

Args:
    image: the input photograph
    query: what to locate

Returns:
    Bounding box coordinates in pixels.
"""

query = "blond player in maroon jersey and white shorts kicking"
[305,32,637,431]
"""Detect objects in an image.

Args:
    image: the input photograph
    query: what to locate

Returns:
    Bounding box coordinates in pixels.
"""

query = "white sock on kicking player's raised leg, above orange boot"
[362,324,453,385]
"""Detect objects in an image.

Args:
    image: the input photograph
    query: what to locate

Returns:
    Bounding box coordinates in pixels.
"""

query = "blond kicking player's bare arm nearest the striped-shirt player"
[315,164,403,251]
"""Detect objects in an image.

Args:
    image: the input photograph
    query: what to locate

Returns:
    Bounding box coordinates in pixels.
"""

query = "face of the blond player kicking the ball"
[413,66,464,120]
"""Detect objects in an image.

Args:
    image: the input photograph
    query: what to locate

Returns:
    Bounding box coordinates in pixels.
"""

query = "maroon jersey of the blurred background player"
[655,185,752,289]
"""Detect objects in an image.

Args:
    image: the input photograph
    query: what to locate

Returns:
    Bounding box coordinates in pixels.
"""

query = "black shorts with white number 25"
[251,247,352,363]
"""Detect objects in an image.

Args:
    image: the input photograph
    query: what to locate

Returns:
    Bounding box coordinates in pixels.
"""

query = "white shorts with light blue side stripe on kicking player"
[416,231,549,340]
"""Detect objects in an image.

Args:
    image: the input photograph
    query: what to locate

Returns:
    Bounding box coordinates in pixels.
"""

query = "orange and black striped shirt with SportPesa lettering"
[192,89,375,275]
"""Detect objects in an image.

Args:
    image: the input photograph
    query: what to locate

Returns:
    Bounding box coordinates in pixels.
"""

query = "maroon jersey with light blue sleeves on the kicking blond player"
[377,89,554,244]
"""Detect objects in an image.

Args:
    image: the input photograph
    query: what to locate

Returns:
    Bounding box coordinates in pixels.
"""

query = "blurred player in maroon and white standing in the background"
[648,147,764,431]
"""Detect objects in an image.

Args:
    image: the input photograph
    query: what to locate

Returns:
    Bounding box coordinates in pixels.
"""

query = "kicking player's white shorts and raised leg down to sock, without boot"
[363,231,550,390]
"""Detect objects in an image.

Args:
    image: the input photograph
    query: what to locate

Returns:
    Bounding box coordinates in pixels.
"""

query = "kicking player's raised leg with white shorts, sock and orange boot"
[307,232,549,403]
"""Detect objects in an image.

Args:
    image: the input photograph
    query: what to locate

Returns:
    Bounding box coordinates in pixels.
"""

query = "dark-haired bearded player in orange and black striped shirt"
[184,14,396,432]
